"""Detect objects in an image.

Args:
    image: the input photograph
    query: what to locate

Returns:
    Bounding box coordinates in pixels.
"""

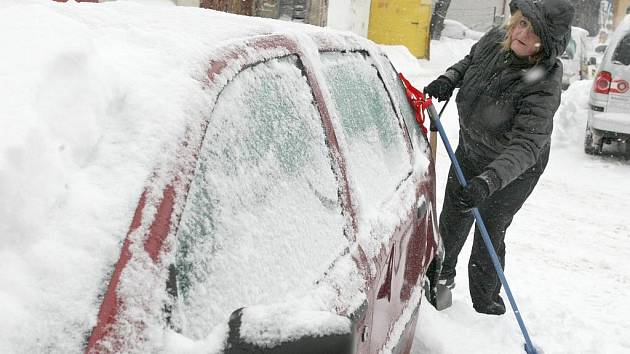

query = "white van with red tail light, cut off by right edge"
[584,15,630,154]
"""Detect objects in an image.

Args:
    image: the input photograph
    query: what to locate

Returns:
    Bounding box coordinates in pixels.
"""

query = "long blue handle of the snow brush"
[427,104,537,354]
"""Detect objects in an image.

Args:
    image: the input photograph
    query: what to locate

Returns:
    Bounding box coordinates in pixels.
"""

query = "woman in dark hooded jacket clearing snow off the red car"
[424,0,574,315]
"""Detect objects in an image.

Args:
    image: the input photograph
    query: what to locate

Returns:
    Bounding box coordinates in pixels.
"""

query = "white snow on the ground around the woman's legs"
[398,38,630,354]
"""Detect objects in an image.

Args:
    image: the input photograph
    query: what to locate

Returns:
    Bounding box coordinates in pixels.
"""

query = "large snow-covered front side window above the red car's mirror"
[174,57,347,339]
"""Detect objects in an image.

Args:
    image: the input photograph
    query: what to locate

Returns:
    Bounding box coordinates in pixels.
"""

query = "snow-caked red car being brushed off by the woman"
[86,16,440,353]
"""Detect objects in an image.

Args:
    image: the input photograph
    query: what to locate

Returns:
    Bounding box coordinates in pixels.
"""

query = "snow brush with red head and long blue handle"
[399,74,544,354]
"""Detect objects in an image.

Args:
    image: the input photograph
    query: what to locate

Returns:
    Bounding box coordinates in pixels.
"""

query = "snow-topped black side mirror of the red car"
[224,308,364,354]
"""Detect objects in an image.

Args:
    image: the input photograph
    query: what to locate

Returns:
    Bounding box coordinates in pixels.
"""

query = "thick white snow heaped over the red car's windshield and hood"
[0,0,386,353]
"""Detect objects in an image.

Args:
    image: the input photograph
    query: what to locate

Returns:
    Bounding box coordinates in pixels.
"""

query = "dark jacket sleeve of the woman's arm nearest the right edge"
[488,60,562,188]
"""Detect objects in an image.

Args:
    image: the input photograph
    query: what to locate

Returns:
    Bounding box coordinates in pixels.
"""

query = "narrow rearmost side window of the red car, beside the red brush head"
[380,55,428,154]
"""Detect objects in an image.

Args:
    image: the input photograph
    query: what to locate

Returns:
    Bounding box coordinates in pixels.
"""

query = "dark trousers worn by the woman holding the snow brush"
[439,149,549,306]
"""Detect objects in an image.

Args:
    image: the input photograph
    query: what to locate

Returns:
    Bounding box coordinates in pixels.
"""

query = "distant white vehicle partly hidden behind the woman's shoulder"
[560,26,589,90]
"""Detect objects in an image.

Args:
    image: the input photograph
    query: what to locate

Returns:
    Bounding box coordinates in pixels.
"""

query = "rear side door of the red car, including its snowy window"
[321,51,428,353]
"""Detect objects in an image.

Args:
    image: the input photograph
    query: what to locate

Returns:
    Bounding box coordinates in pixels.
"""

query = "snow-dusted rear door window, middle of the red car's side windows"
[322,52,411,205]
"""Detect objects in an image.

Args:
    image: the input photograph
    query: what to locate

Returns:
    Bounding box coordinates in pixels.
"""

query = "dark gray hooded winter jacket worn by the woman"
[444,0,574,193]
